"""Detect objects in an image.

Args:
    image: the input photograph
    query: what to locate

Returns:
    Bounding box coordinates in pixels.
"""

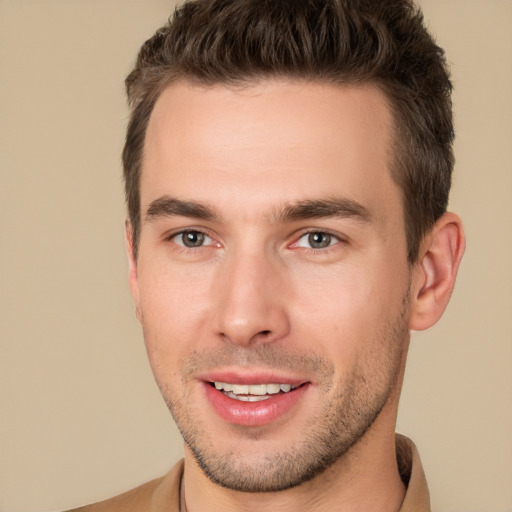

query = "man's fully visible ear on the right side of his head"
[409,213,465,331]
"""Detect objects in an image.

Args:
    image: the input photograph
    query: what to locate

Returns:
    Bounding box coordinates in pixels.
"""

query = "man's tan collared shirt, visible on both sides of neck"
[68,434,431,512]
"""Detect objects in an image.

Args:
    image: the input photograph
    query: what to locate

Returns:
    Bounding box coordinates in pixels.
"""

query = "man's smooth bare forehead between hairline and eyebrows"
[141,80,396,221]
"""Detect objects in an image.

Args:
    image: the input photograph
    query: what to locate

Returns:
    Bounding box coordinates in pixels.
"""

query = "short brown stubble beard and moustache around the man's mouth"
[158,297,409,492]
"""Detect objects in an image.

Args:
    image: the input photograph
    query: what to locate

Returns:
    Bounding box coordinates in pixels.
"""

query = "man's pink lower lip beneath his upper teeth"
[204,382,309,427]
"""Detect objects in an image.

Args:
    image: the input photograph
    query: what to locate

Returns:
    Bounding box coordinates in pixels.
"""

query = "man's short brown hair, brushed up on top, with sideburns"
[123,0,454,262]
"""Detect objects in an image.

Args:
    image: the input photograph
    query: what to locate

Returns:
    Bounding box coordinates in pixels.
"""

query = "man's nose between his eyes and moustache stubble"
[213,247,290,346]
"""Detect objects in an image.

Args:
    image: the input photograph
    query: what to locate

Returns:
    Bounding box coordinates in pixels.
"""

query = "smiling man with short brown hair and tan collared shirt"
[71,0,464,512]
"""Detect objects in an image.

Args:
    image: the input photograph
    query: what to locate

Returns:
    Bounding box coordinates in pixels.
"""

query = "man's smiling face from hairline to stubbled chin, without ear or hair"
[130,81,410,491]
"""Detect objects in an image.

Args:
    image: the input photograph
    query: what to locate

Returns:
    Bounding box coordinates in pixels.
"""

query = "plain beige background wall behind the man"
[0,0,512,512]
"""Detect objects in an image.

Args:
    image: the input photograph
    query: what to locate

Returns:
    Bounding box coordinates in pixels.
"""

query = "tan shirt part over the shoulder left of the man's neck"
[66,461,183,512]
